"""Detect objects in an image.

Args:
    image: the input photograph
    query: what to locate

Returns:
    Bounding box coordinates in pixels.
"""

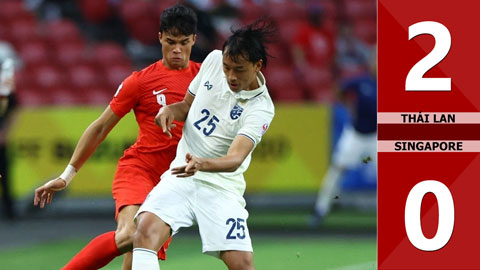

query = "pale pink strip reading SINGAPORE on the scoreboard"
[377,140,480,152]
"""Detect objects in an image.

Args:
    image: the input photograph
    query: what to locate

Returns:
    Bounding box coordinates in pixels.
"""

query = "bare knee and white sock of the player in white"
[132,212,171,270]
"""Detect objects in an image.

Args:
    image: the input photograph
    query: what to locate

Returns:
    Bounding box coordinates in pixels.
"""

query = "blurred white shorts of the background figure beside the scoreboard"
[333,126,377,169]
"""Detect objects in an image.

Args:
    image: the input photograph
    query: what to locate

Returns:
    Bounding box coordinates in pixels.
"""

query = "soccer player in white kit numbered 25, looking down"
[132,20,276,270]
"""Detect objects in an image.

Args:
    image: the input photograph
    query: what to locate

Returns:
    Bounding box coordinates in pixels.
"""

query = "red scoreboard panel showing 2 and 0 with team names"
[377,0,480,269]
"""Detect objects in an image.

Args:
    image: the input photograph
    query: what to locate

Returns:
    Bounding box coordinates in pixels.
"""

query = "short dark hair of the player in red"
[160,4,198,36]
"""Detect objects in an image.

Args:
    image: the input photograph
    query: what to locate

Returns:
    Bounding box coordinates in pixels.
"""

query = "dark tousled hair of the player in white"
[222,18,277,67]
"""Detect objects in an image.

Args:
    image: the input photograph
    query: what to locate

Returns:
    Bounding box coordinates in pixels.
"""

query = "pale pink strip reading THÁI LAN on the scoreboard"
[377,112,480,124]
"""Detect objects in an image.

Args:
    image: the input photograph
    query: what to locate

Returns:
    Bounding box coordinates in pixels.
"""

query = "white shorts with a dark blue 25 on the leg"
[135,171,253,258]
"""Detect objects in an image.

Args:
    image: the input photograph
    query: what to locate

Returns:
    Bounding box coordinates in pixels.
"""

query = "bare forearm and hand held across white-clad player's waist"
[172,135,254,177]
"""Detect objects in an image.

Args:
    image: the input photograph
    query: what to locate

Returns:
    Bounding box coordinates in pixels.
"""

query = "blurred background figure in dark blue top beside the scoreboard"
[310,46,377,227]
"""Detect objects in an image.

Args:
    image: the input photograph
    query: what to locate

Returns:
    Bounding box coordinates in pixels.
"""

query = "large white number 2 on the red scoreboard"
[405,21,452,91]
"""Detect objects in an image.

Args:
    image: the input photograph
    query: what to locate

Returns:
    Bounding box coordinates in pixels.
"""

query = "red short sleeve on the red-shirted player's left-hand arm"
[110,72,140,118]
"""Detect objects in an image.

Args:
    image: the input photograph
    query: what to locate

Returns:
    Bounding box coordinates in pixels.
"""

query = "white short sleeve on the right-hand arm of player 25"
[237,105,274,146]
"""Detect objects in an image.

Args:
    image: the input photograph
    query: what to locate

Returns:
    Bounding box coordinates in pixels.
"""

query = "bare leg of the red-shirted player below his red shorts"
[115,205,140,270]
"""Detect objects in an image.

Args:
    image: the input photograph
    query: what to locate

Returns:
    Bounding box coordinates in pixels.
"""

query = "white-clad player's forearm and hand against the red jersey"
[155,92,195,138]
